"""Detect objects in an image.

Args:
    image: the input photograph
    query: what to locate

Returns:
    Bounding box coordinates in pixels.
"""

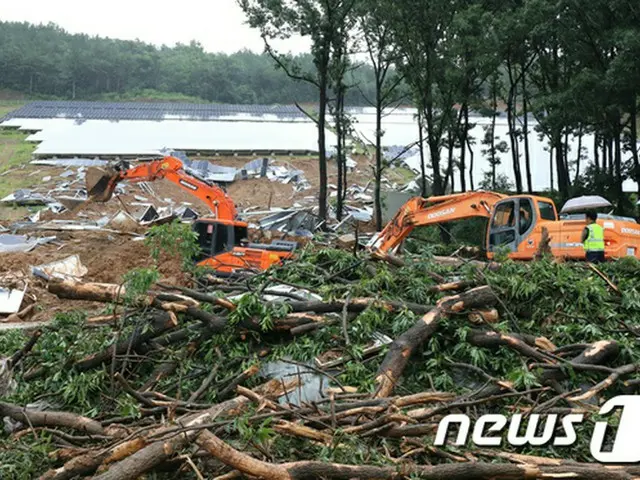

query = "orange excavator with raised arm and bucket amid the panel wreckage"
[85,156,297,274]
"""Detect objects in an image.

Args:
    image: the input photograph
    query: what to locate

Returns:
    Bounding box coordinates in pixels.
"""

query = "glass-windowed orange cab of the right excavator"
[487,196,558,253]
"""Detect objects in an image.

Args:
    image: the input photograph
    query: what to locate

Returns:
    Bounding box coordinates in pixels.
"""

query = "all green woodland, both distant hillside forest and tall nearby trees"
[0,0,640,222]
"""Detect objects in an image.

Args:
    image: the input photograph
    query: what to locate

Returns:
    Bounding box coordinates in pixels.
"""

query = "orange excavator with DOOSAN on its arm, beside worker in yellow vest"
[367,191,640,260]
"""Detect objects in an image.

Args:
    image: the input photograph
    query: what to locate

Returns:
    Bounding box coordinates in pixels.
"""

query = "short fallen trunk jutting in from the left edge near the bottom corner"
[0,402,105,435]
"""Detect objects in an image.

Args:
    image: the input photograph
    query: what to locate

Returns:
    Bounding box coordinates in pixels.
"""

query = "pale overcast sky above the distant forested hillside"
[0,0,307,53]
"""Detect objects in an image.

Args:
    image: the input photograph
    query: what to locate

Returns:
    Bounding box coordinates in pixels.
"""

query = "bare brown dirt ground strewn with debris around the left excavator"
[0,157,400,322]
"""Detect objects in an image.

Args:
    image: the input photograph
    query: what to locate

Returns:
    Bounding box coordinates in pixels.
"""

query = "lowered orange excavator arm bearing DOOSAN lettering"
[368,191,505,255]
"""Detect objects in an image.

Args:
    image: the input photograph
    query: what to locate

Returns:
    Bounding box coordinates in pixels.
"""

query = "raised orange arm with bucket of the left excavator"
[86,156,237,220]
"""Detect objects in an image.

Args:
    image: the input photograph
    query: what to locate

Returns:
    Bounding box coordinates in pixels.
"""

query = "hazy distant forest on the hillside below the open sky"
[0,21,374,105]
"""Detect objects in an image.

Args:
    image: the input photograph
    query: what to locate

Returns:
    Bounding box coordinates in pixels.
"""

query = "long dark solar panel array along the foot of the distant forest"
[0,101,306,121]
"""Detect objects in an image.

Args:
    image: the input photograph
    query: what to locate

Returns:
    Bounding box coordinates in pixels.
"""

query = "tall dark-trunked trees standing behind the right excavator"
[238,0,640,222]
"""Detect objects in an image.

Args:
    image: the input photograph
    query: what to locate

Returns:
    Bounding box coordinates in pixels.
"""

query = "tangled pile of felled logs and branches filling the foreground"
[0,253,640,480]
